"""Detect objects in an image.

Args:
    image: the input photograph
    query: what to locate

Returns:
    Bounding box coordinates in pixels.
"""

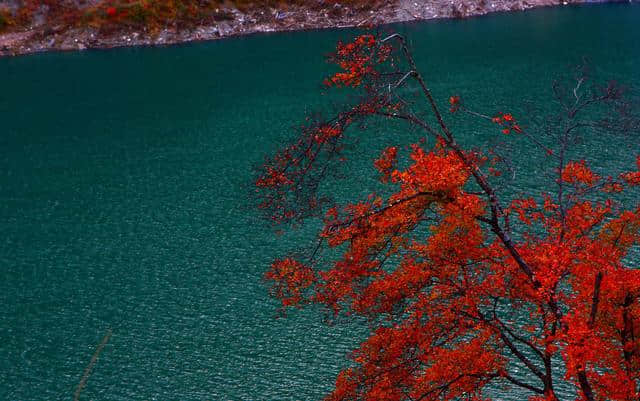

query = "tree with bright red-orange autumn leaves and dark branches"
[256,34,640,401]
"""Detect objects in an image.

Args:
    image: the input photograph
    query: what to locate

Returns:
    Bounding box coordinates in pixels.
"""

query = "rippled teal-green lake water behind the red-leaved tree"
[0,5,640,400]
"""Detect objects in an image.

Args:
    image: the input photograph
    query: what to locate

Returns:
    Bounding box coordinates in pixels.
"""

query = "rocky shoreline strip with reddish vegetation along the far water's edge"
[0,0,633,56]
